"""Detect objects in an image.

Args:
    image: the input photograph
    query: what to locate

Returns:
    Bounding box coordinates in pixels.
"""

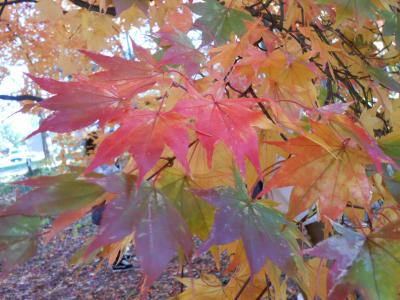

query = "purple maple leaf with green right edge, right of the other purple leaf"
[196,174,296,274]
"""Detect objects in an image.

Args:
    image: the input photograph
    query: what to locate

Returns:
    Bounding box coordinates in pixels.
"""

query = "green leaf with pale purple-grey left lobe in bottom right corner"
[305,222,400,300]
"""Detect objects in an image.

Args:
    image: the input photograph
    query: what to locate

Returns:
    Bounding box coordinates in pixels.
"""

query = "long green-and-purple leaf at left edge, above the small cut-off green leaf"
[0,173,104,216]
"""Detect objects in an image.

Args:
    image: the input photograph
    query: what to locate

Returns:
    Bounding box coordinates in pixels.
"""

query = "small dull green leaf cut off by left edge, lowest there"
[0,216,41,275]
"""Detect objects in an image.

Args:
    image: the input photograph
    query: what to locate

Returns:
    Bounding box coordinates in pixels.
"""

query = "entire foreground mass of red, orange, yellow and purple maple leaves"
[0,0,400,299]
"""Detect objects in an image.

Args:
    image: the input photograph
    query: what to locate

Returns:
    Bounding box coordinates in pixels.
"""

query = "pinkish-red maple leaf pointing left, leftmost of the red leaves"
[28,44,169,137]
